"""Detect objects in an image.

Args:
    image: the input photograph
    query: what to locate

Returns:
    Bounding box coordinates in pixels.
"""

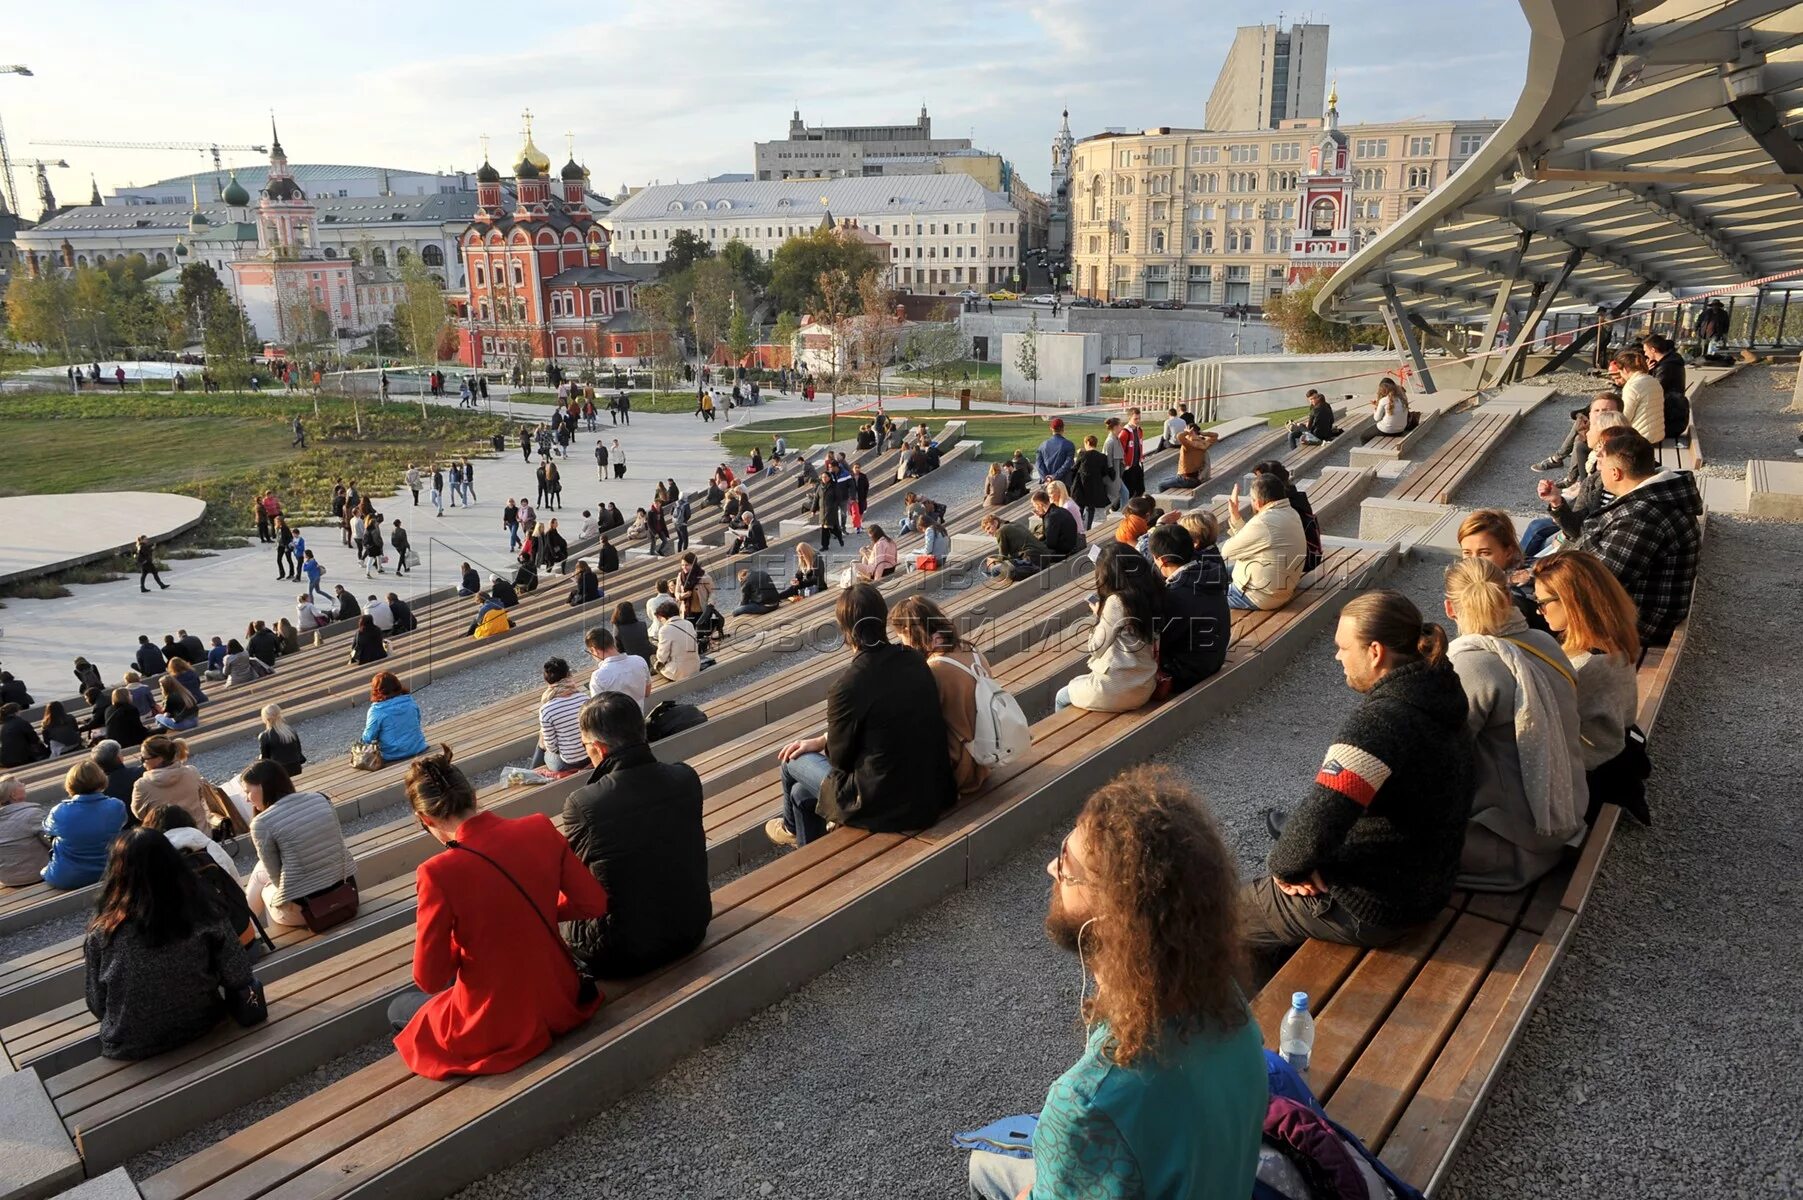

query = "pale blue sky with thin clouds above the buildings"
[0,0,1527,216]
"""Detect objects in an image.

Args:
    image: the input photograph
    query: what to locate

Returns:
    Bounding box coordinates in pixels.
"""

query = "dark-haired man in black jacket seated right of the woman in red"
[563,692,712,978]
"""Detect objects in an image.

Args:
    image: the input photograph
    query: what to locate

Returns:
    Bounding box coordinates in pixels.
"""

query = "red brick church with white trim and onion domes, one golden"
[458,110,651,369]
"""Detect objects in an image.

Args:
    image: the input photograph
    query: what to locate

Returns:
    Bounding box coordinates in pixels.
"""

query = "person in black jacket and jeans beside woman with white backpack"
[764,584,957,845]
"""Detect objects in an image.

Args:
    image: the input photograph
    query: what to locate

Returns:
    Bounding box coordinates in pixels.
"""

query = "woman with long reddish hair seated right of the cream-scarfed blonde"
[1534,550,1652,823]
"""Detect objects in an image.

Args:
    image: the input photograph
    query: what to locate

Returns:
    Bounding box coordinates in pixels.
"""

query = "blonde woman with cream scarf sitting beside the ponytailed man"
[1446,557,1588,892]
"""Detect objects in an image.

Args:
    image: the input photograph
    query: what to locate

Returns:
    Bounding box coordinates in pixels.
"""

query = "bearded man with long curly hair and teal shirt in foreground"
[970,768,1269,1200]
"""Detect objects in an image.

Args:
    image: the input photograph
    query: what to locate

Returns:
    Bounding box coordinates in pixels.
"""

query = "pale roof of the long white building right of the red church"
[613,175,1013,222]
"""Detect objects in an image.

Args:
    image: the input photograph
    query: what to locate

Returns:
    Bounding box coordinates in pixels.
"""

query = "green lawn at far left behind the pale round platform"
[0,393,499,547]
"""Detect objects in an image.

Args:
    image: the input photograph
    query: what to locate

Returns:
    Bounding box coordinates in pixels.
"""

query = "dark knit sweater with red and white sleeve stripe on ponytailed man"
[1269,661,1475,926]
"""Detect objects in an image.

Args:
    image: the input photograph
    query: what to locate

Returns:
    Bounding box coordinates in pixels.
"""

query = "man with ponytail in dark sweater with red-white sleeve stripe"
[1242,591,1475,951]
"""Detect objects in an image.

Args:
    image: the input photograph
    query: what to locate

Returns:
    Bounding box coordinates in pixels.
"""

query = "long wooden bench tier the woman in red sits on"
[130,548,1392,1200]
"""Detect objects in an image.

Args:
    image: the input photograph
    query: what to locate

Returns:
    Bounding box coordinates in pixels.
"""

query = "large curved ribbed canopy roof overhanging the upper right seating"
[1316,0,1803,321]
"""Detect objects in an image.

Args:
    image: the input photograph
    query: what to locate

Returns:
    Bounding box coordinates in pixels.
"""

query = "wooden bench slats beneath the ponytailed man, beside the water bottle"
[1253,587,1688,1195]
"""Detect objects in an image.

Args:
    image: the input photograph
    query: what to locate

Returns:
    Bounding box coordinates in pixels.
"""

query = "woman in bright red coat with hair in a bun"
[388,746,608,1079]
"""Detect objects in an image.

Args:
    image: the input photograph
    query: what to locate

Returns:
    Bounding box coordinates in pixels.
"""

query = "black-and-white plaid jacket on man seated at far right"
[1578,470,1702,645]
